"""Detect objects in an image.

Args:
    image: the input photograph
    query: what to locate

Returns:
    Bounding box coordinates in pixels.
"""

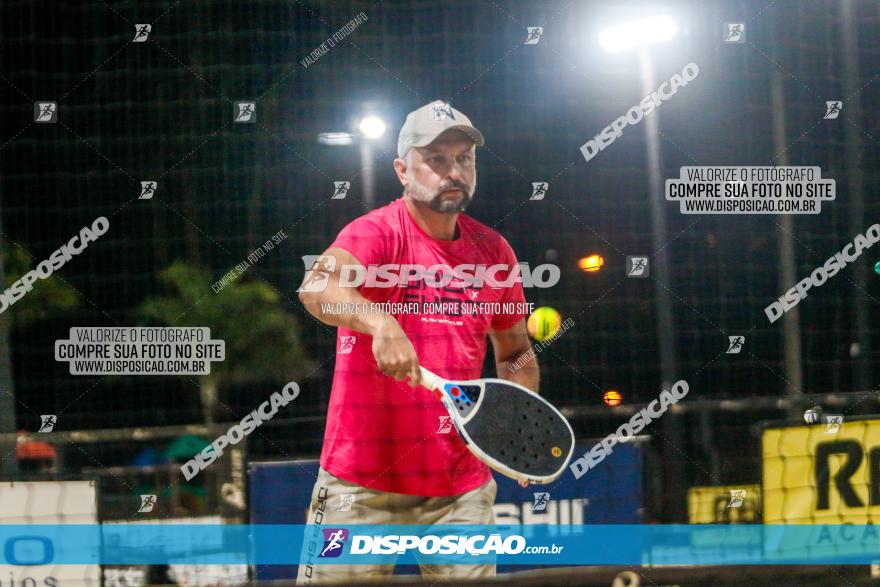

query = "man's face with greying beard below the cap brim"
[405,131,477,214]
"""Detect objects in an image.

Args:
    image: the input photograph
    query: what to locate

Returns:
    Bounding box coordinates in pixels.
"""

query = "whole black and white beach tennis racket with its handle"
[420,367,574,485]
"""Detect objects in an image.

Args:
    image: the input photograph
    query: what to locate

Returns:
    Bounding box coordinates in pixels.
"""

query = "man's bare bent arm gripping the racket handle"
[299,247,421,385]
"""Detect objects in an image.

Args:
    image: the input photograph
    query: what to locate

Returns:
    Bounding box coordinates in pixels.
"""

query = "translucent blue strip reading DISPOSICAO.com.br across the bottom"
[0,524,880,566]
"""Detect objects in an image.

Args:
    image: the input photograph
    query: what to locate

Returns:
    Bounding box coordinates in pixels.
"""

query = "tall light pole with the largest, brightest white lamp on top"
[599,15,686,520]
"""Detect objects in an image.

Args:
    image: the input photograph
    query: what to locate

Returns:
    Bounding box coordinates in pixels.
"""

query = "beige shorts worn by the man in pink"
[297,468,498,585]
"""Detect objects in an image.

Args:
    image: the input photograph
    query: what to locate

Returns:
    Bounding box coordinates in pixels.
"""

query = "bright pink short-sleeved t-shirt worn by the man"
[321,198,527,497]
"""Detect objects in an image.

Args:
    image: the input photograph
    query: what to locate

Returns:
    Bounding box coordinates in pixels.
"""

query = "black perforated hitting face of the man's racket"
[459,380,574,482]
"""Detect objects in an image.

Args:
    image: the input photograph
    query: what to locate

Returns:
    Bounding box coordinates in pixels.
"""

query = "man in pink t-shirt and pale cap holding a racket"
[299,101,539,583]
